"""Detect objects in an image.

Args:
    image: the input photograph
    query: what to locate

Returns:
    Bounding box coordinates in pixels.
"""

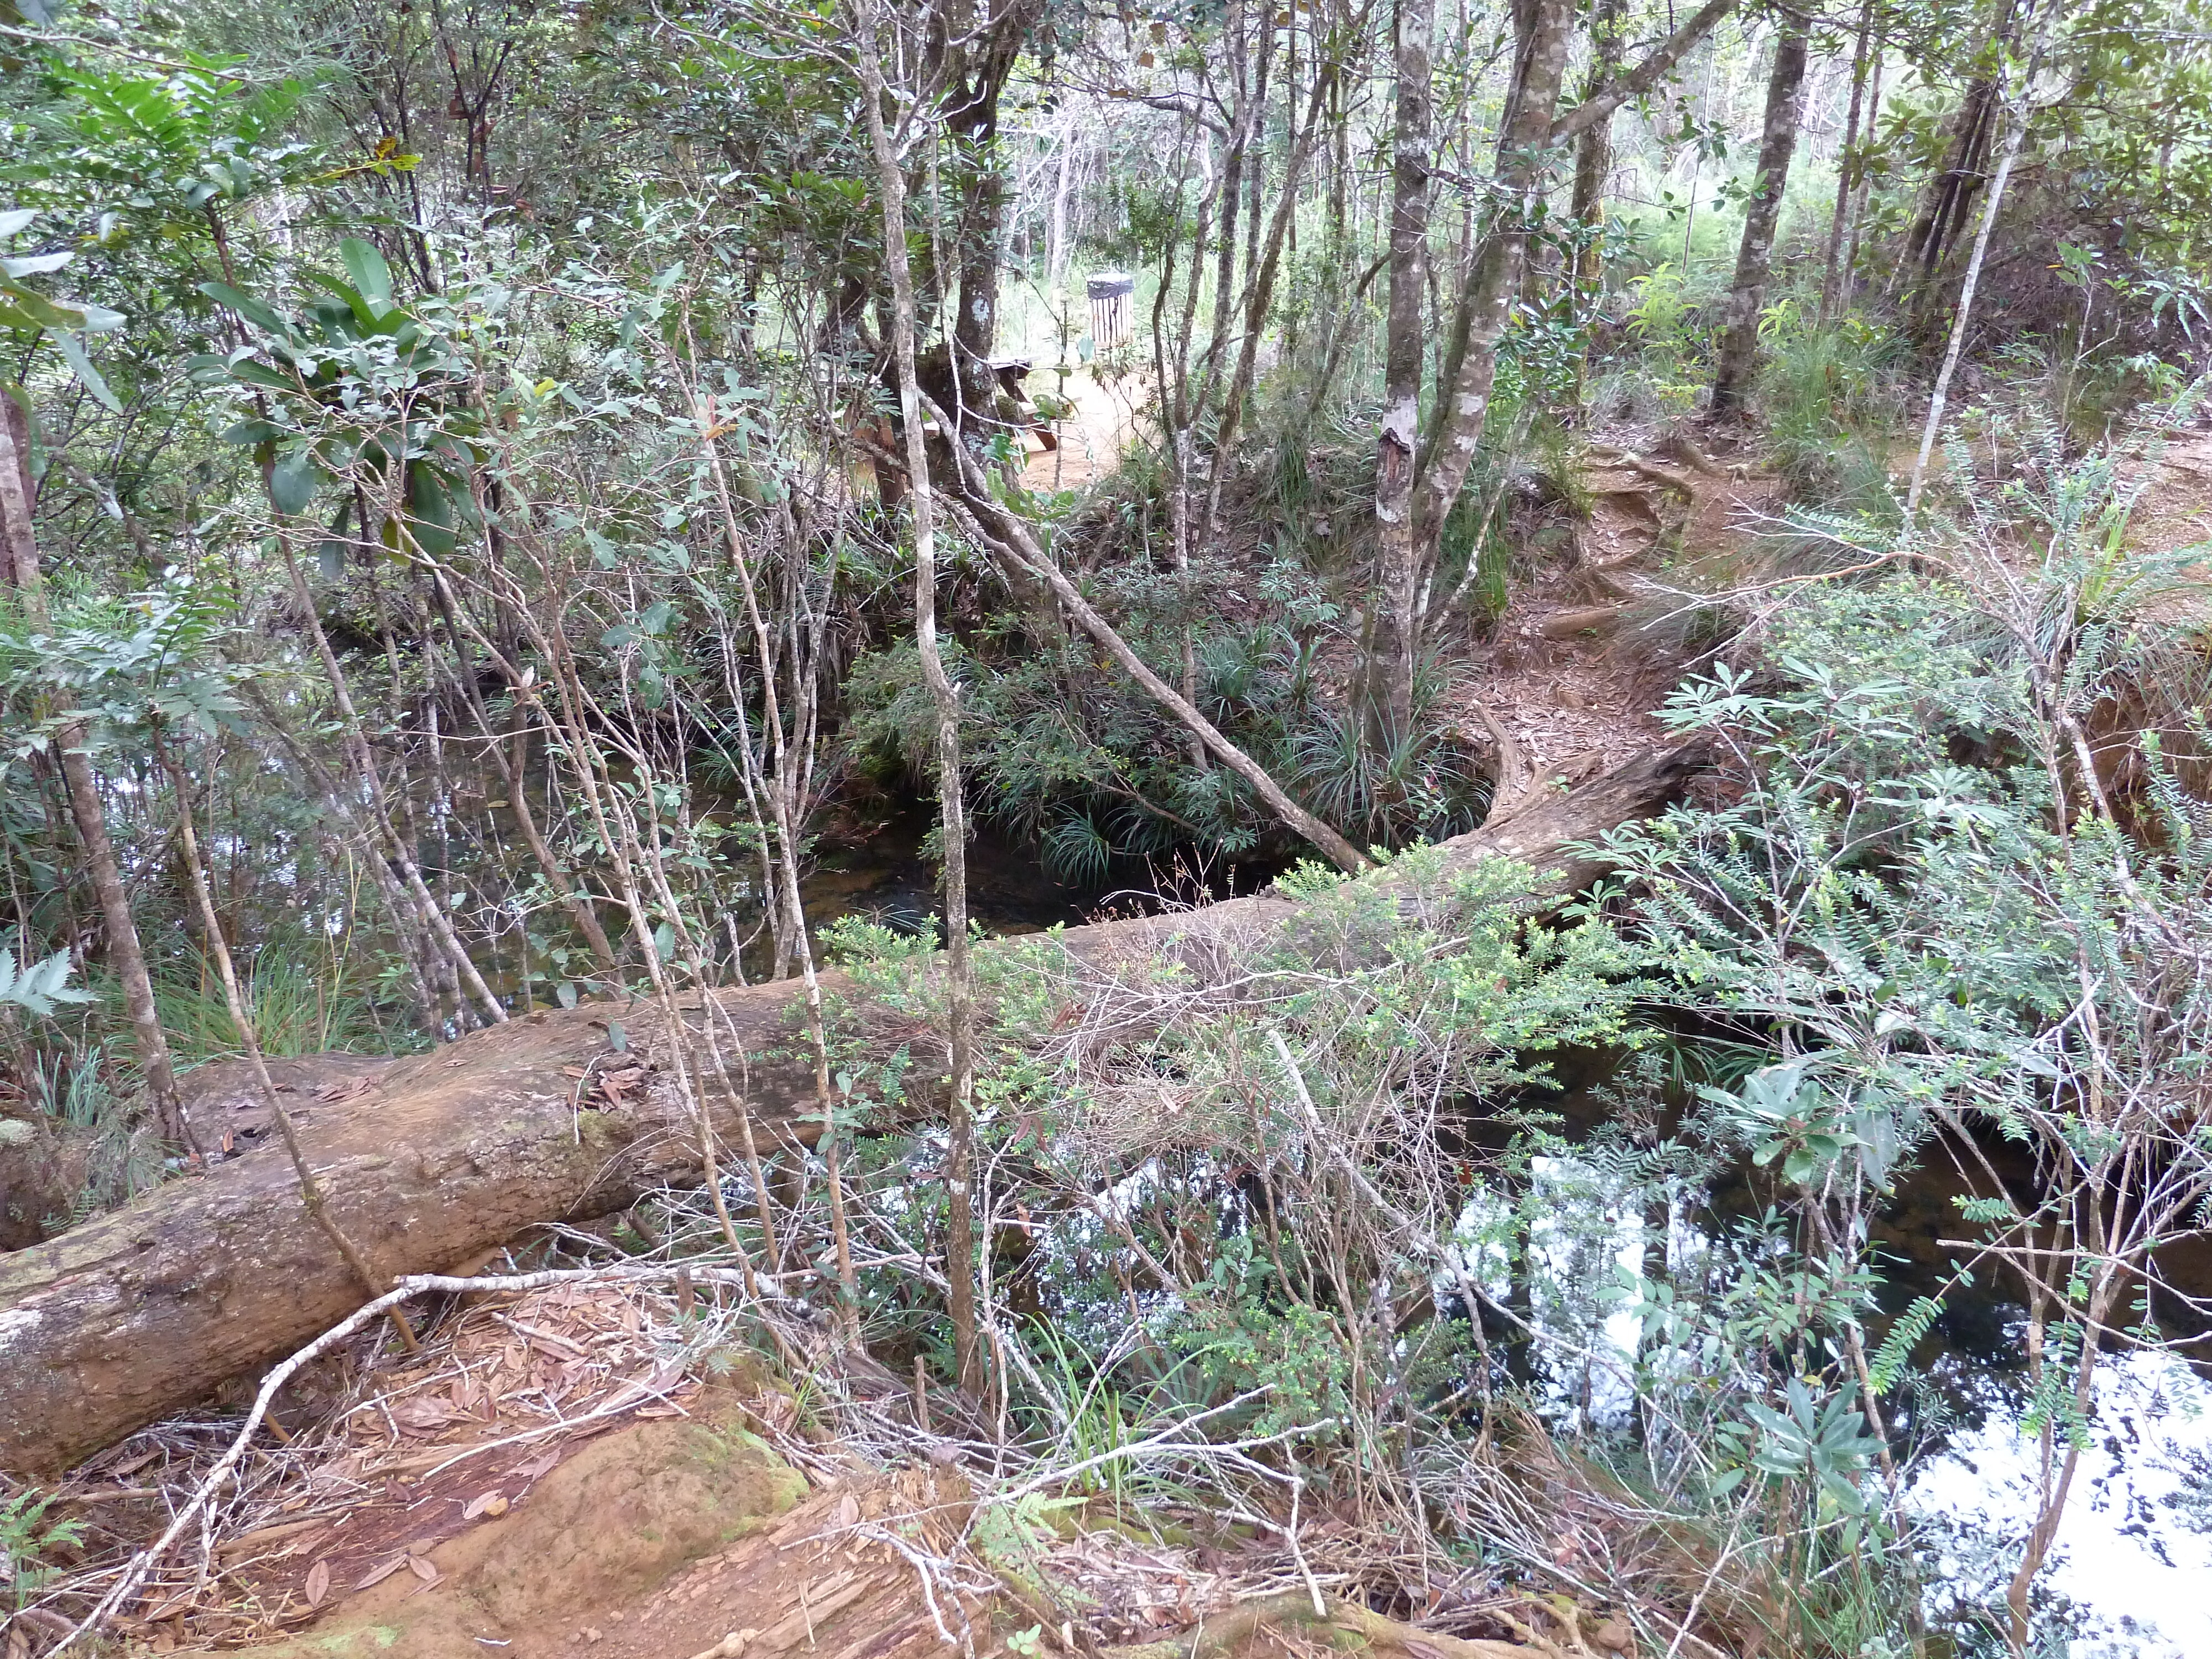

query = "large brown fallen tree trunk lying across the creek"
[0,752,1692,1473]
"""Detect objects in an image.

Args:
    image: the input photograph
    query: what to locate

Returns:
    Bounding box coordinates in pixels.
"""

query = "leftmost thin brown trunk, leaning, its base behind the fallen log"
[0,394,188,1152]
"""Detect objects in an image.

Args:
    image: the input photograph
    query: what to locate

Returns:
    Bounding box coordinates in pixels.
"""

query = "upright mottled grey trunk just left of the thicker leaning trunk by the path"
[1367,0,1436,752]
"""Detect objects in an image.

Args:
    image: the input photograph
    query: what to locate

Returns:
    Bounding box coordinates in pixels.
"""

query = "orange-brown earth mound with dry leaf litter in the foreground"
[91,1283,1575,1659]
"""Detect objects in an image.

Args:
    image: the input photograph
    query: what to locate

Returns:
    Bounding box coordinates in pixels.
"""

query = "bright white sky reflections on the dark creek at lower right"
[1436,1157,2212,1659]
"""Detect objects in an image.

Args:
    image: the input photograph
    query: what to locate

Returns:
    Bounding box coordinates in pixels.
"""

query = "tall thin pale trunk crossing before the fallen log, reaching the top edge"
[856,0,982,1398]
